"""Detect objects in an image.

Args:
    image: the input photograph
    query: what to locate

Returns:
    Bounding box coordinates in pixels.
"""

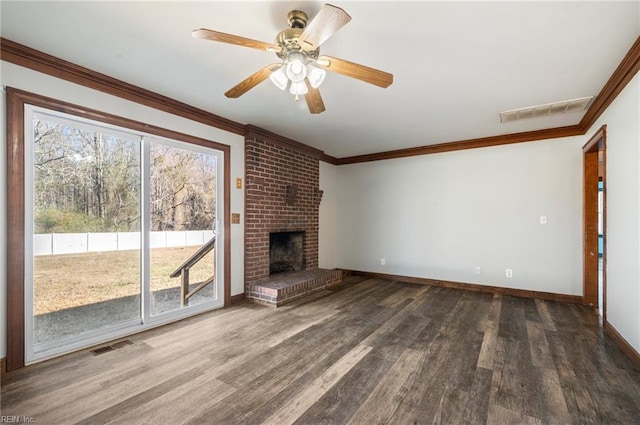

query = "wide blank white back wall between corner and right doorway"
[337,137,582,295]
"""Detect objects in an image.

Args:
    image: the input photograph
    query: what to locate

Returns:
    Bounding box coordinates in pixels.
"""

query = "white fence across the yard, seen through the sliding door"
[33,230,213,255]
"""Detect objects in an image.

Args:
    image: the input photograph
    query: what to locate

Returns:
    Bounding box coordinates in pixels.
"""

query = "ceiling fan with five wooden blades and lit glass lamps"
[192,4,393,114]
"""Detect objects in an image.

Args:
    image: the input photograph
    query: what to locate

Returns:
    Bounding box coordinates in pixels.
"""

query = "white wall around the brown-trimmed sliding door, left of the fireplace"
[0,62,244,357]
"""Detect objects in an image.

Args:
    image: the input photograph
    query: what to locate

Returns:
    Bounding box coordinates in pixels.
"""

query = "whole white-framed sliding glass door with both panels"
[25,107,223,363]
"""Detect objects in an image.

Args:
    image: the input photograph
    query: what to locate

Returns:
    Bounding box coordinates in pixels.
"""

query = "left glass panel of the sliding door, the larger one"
[28,113,141,356]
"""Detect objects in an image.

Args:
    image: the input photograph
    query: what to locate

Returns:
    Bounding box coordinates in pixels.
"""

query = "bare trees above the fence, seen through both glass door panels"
[33,119,216,233]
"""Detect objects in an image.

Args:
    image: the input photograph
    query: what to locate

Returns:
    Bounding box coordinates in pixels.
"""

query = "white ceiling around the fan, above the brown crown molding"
[0,0,640,158]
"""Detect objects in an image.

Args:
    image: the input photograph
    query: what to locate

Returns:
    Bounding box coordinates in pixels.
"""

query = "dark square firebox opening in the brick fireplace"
[269,232,304,274]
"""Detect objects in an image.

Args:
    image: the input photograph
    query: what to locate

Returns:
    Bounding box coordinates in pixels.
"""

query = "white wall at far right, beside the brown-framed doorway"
[584,75,640,352]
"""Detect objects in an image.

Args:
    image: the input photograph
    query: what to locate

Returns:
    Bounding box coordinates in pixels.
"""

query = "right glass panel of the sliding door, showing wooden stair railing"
[149,140,220,315]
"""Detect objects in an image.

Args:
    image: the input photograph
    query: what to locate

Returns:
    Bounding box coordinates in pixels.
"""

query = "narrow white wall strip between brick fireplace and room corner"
[318,161,338,269]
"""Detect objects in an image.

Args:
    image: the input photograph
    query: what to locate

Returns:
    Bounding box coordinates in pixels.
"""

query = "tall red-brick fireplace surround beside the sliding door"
[245,126,341,305]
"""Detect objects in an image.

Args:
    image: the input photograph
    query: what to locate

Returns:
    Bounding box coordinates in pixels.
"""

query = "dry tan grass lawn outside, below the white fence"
[33,246,215,314]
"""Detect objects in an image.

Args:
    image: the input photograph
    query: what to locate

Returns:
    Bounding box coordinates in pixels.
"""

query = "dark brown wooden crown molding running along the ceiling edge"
[0,37,640,165]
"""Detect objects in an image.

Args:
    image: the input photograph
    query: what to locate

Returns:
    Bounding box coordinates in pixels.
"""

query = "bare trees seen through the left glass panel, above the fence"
[33,120,140,233]
